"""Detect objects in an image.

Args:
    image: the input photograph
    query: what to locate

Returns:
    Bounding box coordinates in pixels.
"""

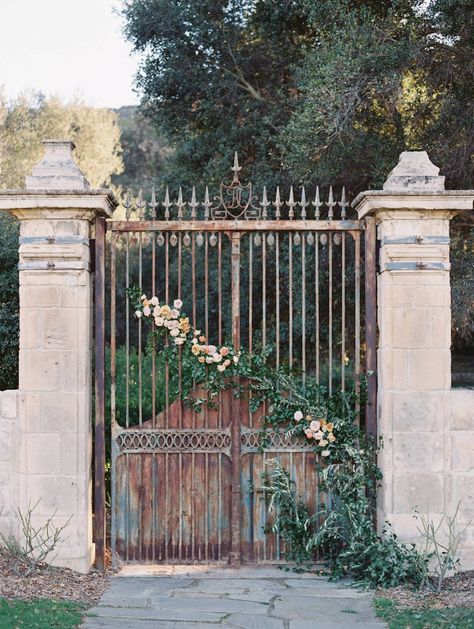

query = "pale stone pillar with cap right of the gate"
[354,151,474,539]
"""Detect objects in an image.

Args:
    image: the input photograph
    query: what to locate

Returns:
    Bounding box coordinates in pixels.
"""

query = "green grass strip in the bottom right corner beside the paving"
[374,598,474,629]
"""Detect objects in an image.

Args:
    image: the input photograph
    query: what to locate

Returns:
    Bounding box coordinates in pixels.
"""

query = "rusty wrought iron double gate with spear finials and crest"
[95,157,375,563]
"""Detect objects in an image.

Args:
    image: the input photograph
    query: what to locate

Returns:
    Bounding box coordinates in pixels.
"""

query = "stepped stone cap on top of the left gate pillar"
[26,140,90,190]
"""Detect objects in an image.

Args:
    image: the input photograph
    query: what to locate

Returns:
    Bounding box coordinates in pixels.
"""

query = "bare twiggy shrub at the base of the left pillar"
[0,500,72,577]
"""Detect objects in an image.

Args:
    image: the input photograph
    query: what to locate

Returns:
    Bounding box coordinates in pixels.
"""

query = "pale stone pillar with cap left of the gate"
[0,140,116,572]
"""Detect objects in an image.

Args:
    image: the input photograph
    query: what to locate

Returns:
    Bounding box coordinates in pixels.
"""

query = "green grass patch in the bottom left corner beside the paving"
[0,598,85,629]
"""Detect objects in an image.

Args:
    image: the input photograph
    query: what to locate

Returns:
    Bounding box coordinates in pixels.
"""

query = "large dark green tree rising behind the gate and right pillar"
[122,0,474,344]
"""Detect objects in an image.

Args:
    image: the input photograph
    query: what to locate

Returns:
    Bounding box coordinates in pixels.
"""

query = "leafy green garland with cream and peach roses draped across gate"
[128,288,428,586]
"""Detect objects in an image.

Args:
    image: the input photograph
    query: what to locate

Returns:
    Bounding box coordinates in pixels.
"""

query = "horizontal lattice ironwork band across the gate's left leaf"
[116,428,231,455]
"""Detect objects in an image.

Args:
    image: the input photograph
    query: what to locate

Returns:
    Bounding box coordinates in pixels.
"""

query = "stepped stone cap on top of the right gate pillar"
[383,151,444,192]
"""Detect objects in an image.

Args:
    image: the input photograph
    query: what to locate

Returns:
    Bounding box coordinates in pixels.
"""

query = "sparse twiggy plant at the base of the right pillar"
[418,502,471,594]
